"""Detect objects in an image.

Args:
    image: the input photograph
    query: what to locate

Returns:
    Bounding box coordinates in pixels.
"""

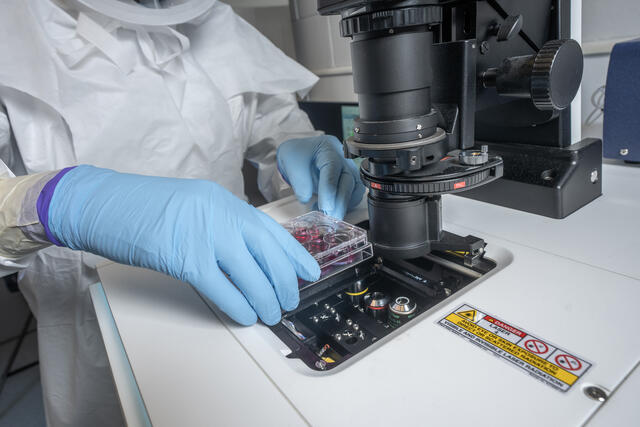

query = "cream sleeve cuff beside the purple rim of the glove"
[0,110,57,276]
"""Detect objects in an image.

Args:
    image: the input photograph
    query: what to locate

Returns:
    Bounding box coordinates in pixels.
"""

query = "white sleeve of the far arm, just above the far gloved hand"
[245,94,322,201]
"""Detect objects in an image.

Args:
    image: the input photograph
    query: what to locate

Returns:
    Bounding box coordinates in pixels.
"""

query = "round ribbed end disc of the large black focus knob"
[531,39,583,110]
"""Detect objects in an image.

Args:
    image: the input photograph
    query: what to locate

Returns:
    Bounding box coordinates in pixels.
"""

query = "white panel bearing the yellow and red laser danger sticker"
[222,221,640,426]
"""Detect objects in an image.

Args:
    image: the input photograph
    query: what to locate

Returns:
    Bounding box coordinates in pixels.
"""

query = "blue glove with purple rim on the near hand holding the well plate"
[38,165,320,325]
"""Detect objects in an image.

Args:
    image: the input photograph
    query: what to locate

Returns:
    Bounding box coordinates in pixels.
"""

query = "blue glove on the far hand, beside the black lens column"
[277,135,364,219]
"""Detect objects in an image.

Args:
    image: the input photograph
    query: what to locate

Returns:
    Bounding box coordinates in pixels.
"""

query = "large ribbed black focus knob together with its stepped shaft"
[481,39,583,111]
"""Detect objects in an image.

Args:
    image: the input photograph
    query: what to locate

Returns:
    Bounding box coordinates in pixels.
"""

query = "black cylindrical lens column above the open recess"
[319,0,510,258]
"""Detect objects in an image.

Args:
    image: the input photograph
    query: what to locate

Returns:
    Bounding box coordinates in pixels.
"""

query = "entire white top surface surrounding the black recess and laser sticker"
[91,164,640,426]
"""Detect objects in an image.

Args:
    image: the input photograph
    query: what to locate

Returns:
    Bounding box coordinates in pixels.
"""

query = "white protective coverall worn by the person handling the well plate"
[0,0,317,426]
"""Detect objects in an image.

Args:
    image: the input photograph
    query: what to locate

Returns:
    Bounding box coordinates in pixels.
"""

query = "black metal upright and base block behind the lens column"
[460,0,602,218]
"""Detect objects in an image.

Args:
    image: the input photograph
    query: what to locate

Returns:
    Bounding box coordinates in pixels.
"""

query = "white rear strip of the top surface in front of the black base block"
[442,164,640,279]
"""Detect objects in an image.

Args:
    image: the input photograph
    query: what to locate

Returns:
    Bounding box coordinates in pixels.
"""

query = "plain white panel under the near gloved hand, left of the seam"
[99,264,305,427]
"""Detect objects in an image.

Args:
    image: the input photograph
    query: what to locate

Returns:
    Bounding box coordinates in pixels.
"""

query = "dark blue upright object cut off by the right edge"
[602,39,640,162]
